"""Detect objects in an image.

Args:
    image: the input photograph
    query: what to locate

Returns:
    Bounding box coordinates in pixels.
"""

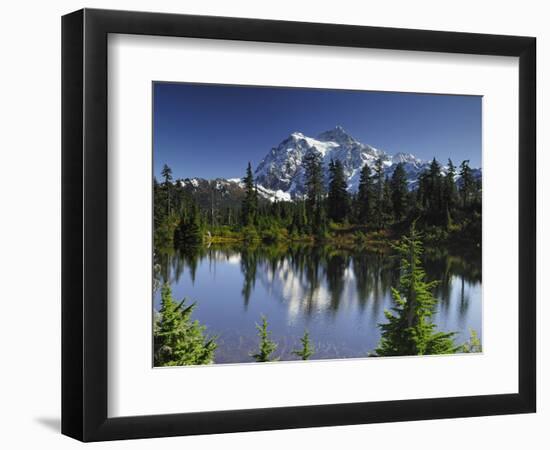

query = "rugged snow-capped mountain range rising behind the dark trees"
[182,126,481,201]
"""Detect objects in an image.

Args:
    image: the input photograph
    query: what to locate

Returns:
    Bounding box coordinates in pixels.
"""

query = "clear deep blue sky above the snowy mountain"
[153,82,481,178]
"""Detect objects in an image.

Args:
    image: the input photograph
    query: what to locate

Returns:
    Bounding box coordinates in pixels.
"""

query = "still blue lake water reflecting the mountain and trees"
[154,246,482,363]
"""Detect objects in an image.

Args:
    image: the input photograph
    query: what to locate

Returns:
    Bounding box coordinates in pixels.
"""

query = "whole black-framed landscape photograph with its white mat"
[62,9,536,441]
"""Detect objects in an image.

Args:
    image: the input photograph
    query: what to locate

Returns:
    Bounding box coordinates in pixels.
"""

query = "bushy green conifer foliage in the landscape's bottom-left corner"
[154,284,217,366]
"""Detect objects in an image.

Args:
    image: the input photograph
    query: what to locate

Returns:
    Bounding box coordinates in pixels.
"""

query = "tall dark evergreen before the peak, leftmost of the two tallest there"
[304,151,325,239]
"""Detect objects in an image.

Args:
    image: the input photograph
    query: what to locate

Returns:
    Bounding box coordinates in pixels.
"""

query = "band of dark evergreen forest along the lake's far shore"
[154,152,481,248]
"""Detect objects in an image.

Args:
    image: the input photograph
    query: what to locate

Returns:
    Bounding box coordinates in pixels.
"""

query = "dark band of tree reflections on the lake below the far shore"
[158,244,481,317]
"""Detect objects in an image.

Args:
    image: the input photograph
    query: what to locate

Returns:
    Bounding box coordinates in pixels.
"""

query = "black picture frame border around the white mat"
[62,9,536,441]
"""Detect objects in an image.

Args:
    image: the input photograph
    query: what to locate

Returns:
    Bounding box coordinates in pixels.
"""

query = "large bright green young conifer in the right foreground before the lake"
[376,223,458,356]
